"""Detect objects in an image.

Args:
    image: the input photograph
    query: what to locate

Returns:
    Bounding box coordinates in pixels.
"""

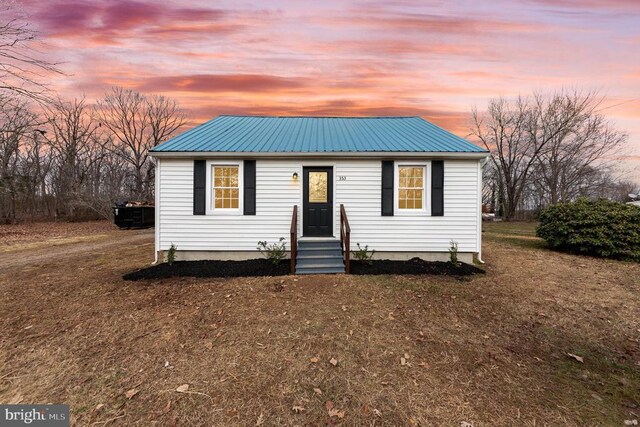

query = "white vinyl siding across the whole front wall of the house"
[156,158,480,252]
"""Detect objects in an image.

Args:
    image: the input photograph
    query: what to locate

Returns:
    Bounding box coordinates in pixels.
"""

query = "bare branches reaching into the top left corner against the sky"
[0,0,61,102]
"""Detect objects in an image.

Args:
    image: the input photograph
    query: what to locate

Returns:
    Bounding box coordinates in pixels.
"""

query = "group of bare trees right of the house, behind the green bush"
[471,90,634,220]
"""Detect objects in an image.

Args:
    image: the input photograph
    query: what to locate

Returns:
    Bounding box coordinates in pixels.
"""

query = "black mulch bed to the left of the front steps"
[122,259,289,281]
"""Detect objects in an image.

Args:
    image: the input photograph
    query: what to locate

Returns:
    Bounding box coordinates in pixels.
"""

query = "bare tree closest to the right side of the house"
[471,91,601,220]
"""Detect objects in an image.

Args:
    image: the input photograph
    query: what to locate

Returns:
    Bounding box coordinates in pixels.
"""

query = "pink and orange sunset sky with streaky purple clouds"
[20,0,640,182]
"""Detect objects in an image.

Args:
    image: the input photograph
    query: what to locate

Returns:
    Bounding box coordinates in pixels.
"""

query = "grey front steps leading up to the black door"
[296,237,344,274]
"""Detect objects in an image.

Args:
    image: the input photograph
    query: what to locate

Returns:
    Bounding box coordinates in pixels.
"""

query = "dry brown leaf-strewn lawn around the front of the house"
[0,224,640,427]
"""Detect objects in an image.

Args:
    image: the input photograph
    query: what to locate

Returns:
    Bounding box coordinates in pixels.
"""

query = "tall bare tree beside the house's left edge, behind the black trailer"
[96,87,186,198]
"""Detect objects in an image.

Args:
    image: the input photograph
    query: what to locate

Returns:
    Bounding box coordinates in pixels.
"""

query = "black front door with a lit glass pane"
[302,167,333,237]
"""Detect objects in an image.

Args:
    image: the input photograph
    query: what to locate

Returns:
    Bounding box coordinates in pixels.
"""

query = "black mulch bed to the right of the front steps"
[351,258,484,276]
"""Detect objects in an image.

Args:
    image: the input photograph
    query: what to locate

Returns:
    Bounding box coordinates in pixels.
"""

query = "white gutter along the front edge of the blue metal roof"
[149,151,489,159]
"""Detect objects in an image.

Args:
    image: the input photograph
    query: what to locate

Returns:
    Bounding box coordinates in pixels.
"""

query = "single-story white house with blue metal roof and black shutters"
[150,116,488,273]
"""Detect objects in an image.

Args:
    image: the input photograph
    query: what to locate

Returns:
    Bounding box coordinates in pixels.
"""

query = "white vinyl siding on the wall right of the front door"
[336,160,480,252]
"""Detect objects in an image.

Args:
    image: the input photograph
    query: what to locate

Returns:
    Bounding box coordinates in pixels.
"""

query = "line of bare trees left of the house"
[0,87,186,222]
